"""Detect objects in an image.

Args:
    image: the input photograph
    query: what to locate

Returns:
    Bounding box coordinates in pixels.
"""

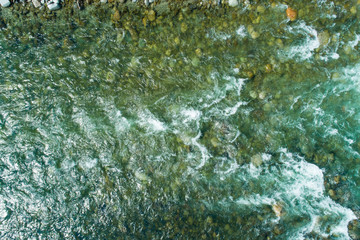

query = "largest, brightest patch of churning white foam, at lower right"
[231,149,356,239]
